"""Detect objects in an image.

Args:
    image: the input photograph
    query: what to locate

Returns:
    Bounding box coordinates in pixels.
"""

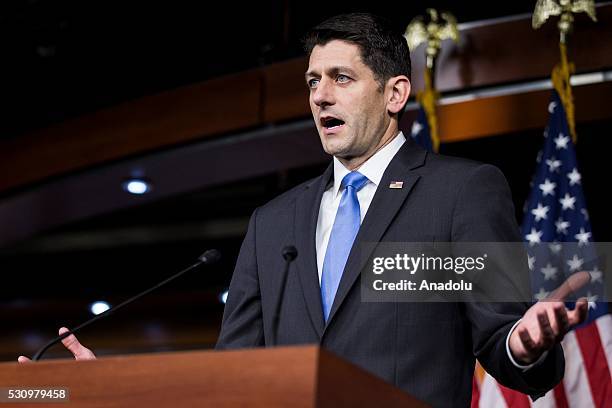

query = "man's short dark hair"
[303,13,411,88]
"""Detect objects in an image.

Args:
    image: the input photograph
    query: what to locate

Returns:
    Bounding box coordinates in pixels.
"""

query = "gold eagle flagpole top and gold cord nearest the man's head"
[404,8,459,152]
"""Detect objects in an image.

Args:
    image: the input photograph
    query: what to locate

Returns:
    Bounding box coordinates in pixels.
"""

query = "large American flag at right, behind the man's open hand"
[472,91,612,407]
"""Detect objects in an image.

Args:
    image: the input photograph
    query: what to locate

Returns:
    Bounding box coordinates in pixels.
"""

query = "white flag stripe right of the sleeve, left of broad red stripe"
[563,331,595,407]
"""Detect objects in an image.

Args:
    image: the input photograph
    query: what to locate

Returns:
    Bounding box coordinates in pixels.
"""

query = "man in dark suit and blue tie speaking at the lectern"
[217,14,586,406]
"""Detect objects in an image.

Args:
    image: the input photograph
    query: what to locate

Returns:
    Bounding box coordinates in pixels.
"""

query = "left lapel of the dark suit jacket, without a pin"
[295,165,333,338]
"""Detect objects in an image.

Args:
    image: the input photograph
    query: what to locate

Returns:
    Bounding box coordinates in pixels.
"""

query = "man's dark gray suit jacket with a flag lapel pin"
[217,140,564,407]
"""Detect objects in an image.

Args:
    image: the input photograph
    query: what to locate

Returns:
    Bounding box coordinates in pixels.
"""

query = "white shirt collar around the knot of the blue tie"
[333,131,406,197]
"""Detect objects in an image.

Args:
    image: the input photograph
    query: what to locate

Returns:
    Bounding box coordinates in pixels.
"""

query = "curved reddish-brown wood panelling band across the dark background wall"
[0,5,612,194]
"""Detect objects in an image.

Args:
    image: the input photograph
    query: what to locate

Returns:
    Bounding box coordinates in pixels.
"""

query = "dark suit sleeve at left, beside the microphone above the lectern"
[216,210,264,349]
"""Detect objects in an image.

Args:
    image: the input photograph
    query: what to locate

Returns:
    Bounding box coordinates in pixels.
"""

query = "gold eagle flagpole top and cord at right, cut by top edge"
[531,0,597,143]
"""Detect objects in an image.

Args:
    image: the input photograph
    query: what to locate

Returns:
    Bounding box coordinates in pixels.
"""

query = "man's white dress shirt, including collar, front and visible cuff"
[316,131,536,371]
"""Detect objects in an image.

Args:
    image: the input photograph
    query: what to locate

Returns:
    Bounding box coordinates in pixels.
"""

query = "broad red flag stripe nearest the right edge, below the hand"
[576,324,612,407]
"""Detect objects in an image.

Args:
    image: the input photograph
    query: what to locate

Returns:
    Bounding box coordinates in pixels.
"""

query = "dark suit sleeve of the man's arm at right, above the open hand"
[452,165,565,397]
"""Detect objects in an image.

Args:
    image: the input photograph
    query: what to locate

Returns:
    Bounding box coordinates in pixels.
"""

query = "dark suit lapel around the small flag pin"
[326,139,427,326]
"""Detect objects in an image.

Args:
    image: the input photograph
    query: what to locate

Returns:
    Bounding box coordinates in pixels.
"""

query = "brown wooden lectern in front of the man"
[0,346,426,408]
